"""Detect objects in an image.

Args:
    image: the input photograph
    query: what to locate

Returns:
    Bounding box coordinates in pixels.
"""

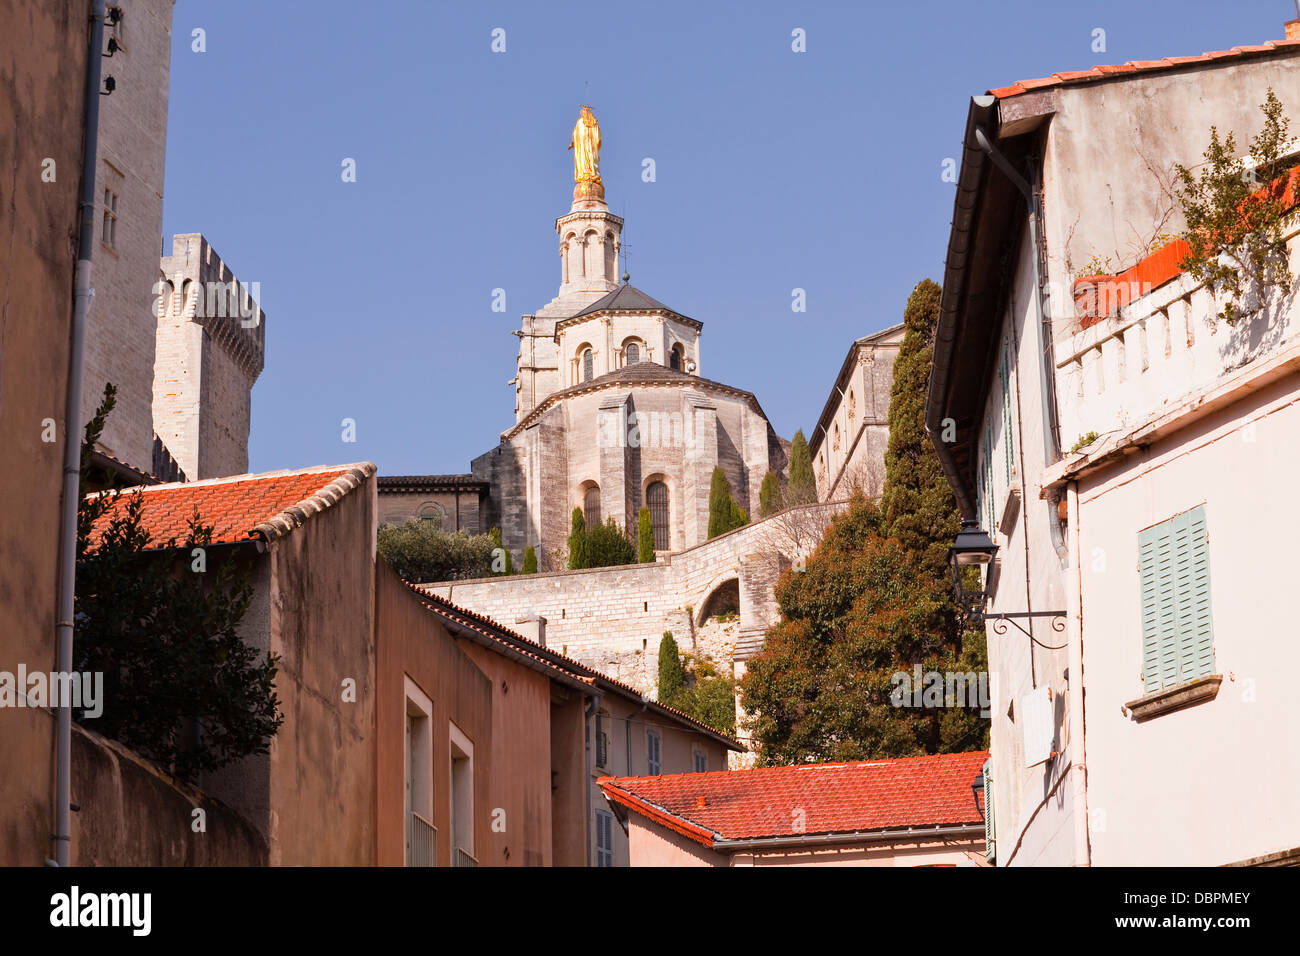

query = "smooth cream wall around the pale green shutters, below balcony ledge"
[1079,375,1300,865]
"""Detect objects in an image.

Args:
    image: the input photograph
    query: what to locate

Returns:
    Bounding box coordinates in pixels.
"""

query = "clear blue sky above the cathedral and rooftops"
[164,0,1296,475]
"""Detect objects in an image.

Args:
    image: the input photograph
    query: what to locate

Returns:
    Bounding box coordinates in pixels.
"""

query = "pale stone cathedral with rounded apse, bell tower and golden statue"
[380,107,789,571]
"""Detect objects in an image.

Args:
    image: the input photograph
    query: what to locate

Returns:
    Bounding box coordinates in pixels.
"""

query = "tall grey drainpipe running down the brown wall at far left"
[53,0,105,866]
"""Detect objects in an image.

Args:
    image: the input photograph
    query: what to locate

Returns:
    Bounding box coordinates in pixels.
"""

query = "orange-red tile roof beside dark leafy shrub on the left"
[87,462,374,548]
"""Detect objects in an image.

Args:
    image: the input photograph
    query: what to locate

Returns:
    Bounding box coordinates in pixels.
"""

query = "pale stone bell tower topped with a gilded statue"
[511,107,623,421]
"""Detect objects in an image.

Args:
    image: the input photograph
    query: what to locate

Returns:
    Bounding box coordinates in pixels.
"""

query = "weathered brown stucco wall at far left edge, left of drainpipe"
[0,0,88,866]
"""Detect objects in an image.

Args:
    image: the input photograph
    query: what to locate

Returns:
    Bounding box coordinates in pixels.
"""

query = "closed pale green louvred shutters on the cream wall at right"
[1138,505,1214,693]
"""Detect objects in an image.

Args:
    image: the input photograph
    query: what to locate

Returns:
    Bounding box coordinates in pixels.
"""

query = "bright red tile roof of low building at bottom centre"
[599,750,988,847]
